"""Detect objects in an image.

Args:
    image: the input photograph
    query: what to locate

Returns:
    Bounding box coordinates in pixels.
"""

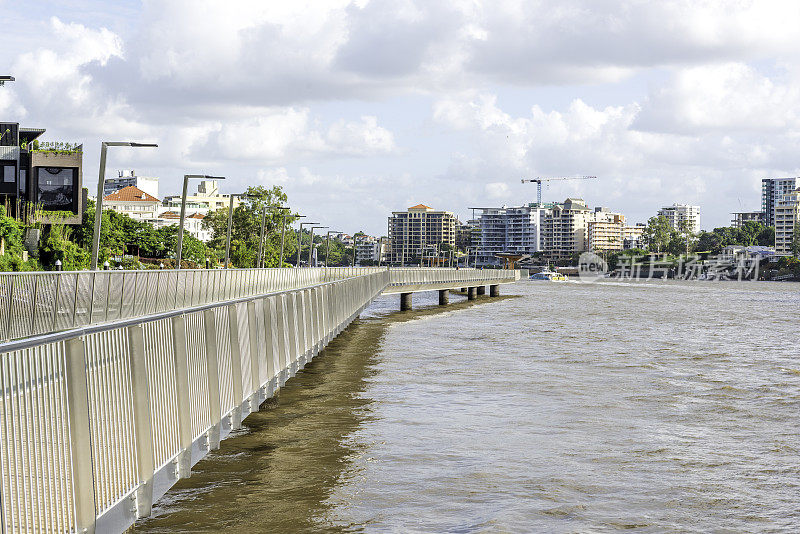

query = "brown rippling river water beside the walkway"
[135,281,800,533]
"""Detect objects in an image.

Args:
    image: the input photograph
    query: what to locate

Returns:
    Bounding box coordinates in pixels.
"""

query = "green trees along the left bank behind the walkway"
[0,186,353,271]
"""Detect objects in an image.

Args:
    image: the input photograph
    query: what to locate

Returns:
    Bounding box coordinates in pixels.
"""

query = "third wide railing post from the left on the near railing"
[172,315,192,478]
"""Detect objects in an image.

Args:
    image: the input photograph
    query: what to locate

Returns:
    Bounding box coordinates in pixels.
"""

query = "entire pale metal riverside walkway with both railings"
[0,267,520,532]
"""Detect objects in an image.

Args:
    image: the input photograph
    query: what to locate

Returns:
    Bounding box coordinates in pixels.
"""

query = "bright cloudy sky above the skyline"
[0,0,800,234]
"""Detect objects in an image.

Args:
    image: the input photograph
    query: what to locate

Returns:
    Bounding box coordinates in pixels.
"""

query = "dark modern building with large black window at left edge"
[0,122,85,224]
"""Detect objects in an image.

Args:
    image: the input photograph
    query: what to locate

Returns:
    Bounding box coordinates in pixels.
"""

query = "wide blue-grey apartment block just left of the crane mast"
[476,204,545,265]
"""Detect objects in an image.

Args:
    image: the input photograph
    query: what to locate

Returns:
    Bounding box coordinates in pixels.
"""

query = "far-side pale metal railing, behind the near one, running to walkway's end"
[0,267,518,340]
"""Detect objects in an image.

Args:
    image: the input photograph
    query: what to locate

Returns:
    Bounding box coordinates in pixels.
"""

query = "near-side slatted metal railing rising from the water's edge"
[0,269,389,532]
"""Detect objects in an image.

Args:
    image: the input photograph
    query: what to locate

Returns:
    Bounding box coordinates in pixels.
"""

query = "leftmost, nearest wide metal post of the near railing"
[64,337,97,534]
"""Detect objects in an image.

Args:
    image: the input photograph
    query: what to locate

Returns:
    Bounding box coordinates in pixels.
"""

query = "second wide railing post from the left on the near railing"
[128,324,155,518]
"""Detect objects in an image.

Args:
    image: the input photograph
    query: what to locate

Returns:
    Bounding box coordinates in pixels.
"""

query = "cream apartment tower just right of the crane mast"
[540,198,594,260]
